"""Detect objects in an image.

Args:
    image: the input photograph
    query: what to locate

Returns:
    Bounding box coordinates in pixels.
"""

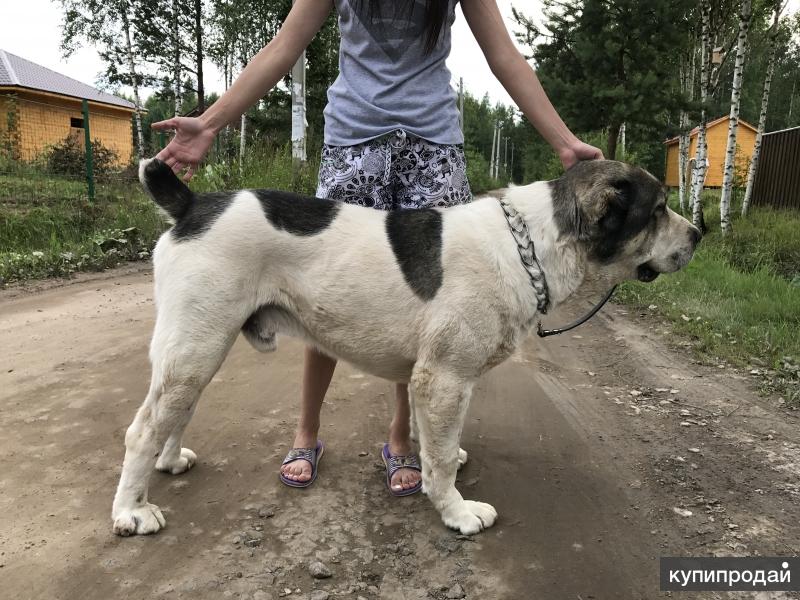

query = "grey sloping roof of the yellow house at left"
[0,49,135,110]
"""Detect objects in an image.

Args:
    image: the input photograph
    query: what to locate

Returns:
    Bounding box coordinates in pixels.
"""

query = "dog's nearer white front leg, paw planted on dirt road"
[411,365,497,535]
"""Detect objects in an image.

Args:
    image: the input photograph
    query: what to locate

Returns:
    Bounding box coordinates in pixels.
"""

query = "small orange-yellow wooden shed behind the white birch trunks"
[664,116,756,187]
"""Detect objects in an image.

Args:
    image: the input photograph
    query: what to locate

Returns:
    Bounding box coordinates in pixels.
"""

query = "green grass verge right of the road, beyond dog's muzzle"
[617,193,800,406]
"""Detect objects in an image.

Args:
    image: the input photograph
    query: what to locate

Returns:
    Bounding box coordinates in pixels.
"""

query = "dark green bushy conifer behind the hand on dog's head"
[514,0,693,158]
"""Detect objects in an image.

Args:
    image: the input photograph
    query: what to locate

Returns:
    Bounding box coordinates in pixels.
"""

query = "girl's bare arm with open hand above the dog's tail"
[153,0,333,179]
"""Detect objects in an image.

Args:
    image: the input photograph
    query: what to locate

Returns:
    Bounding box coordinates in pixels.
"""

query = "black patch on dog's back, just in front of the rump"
[253,190,339,236]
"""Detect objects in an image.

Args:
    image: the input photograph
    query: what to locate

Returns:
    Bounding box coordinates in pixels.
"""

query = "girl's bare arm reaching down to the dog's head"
[461,0,603,169]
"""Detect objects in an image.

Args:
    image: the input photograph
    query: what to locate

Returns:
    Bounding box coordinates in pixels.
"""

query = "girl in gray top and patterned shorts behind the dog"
[153,0,602,496]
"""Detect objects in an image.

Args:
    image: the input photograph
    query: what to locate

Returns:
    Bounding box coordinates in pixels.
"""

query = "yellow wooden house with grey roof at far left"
[0,50,134,166]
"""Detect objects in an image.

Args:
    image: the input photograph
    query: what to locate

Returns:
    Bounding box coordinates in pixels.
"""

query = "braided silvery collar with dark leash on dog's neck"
[498,199,617,338]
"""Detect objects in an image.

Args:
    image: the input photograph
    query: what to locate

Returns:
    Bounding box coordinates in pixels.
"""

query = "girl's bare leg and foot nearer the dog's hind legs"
[281,347,336,482]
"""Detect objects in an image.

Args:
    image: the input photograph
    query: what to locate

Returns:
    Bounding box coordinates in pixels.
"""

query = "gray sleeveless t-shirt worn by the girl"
[325,0,464,146]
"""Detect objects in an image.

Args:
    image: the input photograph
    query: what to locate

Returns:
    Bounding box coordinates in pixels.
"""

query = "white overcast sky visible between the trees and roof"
[0,0,800,109]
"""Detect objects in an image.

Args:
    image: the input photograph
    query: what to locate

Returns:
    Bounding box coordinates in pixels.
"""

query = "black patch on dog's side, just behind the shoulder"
[386,209,444,301]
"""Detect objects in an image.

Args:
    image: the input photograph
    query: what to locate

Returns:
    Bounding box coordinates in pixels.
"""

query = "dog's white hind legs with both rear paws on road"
[111,308,243,535]
